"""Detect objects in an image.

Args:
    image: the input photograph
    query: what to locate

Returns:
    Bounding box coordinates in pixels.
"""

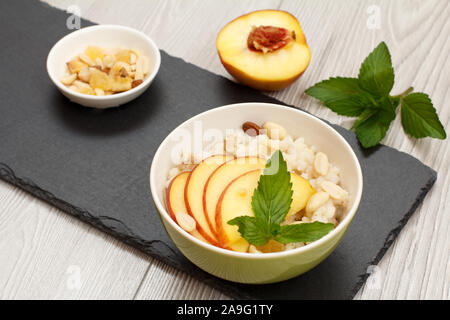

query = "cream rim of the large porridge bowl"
[150,102,363,260]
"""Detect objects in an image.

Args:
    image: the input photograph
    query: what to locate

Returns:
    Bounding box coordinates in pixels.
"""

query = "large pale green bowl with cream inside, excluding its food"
[150,103,363,284]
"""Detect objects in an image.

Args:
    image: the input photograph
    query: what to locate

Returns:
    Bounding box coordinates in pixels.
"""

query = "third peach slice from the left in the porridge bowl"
[203,157,266,234]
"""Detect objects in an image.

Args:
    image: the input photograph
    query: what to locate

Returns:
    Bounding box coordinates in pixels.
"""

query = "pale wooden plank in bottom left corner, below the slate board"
[0,182,150,299]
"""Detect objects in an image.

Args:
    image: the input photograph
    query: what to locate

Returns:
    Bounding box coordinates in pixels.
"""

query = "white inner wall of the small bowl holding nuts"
[47,25,160,97]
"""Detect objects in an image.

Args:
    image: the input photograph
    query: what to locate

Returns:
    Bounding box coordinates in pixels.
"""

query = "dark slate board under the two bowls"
[0,0,436,299]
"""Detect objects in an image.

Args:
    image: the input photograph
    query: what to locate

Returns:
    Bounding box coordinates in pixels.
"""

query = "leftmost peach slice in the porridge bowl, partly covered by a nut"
[166,172,209,243]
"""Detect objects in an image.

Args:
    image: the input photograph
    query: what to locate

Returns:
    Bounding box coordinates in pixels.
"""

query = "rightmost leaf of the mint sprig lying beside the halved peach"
[401,93,447,139]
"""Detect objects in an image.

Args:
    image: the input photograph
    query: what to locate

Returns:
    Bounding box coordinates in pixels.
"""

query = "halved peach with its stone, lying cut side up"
[216,10,311,90]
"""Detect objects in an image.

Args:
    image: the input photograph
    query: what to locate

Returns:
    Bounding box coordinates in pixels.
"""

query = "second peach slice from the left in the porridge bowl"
[183,155,231,243]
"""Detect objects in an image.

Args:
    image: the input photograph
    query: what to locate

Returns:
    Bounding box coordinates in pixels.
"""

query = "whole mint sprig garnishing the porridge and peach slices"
[228,150,334,246]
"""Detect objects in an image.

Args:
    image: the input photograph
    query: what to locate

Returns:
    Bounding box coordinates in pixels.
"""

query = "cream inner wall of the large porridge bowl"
[150,103,362,252]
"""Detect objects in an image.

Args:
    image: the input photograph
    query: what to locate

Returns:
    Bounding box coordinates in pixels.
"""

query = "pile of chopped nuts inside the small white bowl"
[61,46,150,96]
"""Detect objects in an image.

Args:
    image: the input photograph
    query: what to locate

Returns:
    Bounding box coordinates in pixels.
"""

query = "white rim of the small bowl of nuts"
[46,24,161,101]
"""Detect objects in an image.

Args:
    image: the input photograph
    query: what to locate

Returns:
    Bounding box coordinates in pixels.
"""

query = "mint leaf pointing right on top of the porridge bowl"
[275,221,334,244]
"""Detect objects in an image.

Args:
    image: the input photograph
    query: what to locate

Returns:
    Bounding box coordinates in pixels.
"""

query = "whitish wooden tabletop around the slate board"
[0,0,450,299]
